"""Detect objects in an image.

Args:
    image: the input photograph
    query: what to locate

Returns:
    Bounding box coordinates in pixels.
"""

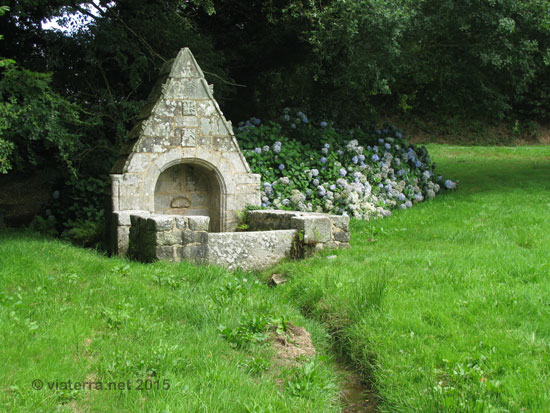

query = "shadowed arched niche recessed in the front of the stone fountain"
[154,163,222,232]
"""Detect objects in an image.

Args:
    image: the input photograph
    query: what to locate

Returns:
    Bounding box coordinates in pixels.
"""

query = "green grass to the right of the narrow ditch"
[277,145,550,412]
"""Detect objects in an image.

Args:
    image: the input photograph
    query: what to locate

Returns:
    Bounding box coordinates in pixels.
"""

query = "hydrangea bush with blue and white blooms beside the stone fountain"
[237,109,457,220]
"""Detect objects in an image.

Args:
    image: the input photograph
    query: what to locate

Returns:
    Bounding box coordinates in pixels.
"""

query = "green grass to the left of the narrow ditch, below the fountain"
[0,232,339,412]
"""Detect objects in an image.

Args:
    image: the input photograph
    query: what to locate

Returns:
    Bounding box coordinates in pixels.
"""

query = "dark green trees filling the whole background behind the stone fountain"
[0,0,550,238]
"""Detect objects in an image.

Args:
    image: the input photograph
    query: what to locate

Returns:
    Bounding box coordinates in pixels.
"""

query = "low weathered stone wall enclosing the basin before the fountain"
[123,210,349,270]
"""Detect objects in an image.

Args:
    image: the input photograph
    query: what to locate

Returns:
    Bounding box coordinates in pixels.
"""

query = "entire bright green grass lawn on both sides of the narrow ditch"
[0,145,550,412]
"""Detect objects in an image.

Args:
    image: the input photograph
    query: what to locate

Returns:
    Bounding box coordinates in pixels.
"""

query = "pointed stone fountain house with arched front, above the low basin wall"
[111,49,260,254]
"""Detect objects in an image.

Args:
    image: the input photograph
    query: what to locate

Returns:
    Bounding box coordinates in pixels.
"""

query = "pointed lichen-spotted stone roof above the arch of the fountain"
[111,48,250,174]
